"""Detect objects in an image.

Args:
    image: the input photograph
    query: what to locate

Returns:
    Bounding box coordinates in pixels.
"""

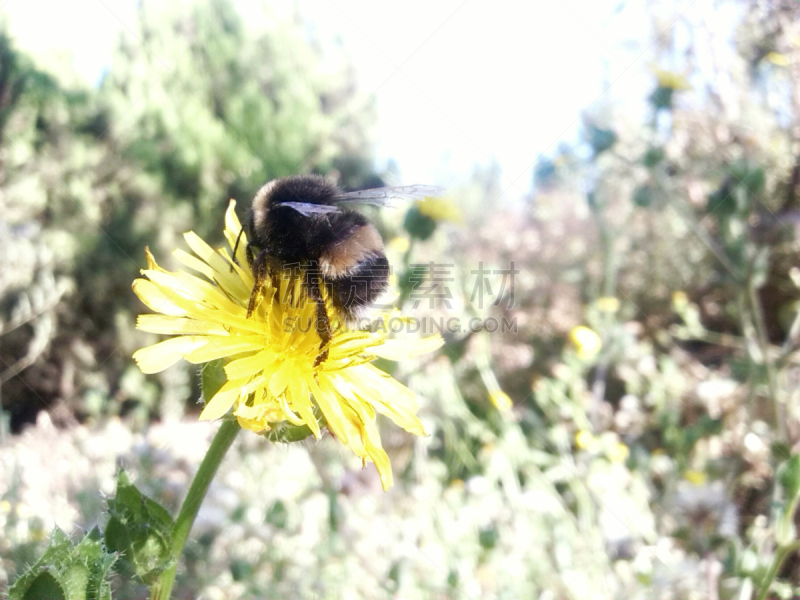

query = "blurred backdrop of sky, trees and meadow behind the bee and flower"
[0,0,800,600]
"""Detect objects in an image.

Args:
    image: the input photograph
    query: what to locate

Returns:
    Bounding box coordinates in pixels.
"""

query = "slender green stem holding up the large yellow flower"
[150,420,241,600]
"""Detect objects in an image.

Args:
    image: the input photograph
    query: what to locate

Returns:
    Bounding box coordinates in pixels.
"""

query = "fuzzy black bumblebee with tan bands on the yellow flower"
[234,175,441,366]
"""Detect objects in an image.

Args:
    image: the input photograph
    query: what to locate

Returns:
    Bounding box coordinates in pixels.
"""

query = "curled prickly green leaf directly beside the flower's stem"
[105,471,175,584]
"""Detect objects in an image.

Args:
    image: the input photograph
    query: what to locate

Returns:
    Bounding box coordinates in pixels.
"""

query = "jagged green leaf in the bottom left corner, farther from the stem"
[9,529,116,600]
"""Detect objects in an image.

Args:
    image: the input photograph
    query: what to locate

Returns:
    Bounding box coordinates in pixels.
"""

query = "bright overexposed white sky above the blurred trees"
[0,0,664,197]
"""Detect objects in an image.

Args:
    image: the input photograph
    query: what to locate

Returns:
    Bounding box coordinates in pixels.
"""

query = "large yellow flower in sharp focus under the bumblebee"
[133,201,442,490]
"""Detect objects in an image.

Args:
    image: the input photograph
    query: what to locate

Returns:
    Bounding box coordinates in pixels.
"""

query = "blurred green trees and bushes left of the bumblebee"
[0,2,380,429]
